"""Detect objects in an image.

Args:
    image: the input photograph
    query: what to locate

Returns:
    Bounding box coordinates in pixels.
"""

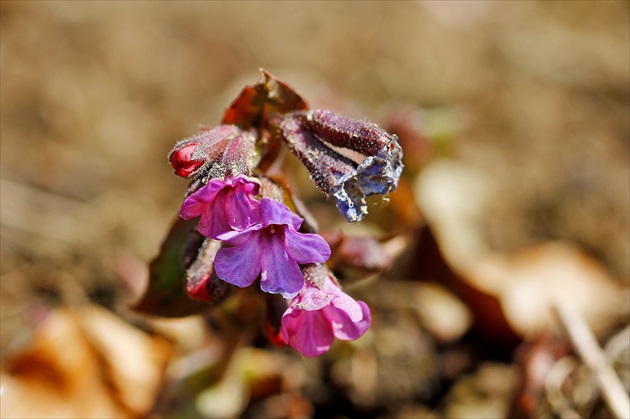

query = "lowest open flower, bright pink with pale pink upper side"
[281,266,371,356]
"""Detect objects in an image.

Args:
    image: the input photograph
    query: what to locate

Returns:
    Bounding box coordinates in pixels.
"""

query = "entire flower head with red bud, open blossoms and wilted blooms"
[157,73,402,356]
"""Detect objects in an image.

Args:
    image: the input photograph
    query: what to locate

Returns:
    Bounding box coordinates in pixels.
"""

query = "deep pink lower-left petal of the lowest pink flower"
[282,308,334,356]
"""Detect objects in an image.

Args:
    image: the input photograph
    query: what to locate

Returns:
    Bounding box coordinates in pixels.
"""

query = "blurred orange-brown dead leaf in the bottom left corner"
[0,306,171,418]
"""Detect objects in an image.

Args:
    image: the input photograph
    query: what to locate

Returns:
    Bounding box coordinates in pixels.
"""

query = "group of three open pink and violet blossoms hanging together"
[180,175,370,356]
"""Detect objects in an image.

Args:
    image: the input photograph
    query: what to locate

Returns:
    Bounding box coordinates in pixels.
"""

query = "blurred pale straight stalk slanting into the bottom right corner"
[555,301,630,418]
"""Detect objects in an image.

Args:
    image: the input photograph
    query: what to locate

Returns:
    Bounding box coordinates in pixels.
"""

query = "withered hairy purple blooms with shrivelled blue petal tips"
[277,110,403,222]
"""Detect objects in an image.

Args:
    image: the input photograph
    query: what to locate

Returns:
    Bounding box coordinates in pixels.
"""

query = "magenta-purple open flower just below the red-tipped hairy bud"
[179,175,260,239]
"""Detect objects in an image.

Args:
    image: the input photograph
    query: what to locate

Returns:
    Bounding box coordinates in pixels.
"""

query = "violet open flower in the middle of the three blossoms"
[214,198,330,298]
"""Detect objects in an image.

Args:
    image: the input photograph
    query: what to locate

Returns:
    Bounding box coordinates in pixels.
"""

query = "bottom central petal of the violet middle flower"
[259,235,304,298]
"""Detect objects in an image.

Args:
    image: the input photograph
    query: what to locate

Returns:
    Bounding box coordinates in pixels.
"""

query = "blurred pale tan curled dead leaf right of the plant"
[412,160,622,345]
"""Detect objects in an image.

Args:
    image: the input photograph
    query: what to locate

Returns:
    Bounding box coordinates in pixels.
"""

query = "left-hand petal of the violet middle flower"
[214,232,260,287]
